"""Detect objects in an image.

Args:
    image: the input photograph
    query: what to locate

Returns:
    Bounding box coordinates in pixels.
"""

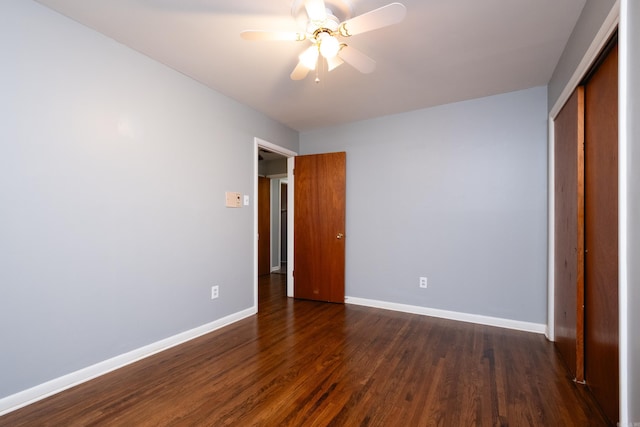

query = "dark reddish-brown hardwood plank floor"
[0,274,606,426]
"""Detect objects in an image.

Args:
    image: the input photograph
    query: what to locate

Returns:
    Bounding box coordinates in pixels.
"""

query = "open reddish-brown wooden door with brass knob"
[293,152,346,303]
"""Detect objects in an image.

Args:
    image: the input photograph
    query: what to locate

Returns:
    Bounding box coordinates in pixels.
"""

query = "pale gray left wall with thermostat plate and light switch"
[0,0,298,397]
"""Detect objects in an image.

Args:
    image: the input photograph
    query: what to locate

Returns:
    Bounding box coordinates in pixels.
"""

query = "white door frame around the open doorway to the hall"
[253,137,298,311]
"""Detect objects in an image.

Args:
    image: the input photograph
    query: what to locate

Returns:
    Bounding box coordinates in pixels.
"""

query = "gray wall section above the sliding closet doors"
[548,0,616,110]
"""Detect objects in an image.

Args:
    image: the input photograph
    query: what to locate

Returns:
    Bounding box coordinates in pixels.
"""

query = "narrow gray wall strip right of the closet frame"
[625,0,640,423]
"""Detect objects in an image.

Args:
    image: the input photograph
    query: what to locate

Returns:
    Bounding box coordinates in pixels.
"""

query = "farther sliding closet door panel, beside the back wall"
[554,86,584,382]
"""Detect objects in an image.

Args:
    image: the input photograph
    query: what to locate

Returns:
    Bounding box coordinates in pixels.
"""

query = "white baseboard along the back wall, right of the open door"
[345,297,547,334]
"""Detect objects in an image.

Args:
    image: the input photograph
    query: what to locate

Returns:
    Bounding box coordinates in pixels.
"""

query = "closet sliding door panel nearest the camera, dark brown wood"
[585,41,619,424]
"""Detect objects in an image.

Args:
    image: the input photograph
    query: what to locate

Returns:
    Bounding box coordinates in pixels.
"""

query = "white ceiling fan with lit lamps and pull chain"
[240,0,407,81]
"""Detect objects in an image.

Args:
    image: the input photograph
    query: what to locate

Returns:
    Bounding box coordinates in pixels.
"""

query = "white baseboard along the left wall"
[0,307,257,416]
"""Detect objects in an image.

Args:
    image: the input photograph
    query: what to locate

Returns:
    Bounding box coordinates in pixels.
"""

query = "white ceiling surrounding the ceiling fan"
[37,0,585,131]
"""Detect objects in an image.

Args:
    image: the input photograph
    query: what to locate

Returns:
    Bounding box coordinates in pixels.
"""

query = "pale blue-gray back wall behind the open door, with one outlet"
[300,87,547,324]
